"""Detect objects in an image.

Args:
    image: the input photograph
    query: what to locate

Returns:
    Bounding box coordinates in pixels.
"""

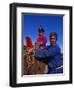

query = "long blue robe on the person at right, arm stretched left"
[35,44,63,74]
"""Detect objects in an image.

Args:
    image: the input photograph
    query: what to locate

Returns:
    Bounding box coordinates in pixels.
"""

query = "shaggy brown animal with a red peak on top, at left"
[23,37,48,75]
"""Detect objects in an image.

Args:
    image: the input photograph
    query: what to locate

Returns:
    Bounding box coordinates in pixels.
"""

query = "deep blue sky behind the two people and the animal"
[23,14,63,51]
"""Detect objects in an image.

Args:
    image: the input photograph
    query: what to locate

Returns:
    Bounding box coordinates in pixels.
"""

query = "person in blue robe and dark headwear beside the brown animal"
[35,32,63,74]
